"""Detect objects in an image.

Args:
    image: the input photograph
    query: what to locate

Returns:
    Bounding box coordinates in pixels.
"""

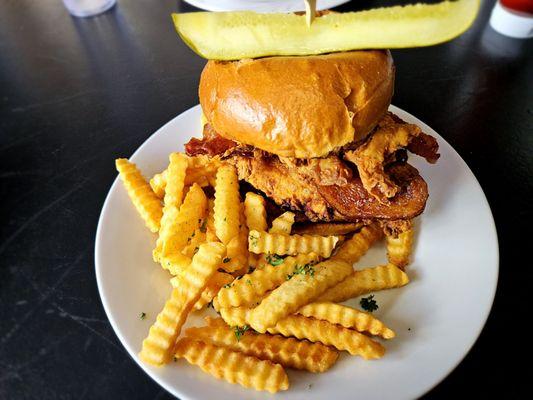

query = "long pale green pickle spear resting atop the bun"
[172,0,479,60]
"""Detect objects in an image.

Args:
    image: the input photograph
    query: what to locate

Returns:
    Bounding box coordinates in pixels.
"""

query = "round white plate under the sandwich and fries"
[95,106,498,400]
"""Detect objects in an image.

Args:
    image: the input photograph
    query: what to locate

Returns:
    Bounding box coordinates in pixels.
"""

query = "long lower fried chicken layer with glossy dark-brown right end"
[229,151,428,221]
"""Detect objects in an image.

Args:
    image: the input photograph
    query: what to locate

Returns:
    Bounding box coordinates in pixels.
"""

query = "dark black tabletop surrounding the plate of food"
[0,0,533,399]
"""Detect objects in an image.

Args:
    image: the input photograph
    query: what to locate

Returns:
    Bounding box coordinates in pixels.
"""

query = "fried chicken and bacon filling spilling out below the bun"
[185,113,439,225]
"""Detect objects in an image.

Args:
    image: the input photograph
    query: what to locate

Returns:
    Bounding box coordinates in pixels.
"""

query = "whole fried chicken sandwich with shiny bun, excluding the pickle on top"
[186,51,439,231]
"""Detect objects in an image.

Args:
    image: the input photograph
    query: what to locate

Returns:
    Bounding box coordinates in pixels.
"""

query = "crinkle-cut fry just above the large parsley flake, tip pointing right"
[317,264,409,303]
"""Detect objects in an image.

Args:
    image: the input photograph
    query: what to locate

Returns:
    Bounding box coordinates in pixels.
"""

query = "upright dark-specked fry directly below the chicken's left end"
[214,164,240,245]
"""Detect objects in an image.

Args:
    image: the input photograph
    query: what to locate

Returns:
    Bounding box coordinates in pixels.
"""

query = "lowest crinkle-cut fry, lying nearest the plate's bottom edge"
[175,337,289,393]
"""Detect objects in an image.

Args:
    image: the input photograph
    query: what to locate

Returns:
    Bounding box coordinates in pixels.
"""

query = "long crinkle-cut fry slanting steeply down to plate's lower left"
[139,243,226,365]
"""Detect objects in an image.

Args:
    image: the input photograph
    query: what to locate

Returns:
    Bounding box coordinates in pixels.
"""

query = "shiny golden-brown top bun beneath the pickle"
[199,51,394,158]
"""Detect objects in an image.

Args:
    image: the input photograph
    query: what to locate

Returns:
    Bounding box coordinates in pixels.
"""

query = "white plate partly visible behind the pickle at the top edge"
[185,0,348,12]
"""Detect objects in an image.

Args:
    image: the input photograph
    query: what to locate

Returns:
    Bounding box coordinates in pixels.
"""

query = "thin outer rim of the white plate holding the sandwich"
[94,104,500,400]
